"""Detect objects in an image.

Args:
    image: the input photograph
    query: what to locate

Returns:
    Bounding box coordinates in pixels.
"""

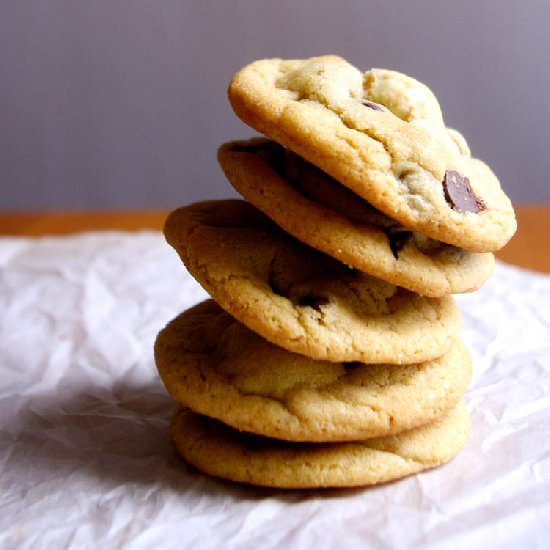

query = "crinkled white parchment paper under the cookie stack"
[0,233,550,549]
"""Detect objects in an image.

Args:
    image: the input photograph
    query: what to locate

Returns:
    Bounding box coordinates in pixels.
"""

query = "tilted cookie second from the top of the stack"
[218,139,495,297]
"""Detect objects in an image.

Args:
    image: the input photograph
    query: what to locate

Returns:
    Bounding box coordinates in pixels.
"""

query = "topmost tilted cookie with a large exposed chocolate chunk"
[228,56,516,252]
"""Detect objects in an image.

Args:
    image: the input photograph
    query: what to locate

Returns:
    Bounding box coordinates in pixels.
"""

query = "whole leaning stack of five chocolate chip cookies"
[155,56,516,488]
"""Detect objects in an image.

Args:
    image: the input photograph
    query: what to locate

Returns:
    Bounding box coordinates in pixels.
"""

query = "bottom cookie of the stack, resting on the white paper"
[171,403,470,489]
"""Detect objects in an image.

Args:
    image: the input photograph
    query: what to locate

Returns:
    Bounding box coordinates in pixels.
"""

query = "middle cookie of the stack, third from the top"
[164,200,459,364]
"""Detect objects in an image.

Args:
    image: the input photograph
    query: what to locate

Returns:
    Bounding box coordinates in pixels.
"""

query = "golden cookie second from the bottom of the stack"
[155,300,471,441]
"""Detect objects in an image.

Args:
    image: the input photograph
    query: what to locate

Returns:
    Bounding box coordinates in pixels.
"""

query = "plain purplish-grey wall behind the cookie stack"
[0,0,550,210]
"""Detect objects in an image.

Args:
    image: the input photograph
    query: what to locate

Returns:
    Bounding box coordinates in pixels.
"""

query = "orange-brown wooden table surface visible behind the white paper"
[0,204,550,273]
